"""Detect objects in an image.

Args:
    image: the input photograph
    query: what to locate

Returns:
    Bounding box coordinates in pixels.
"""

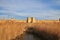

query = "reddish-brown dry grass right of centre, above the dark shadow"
[34,21,60,36]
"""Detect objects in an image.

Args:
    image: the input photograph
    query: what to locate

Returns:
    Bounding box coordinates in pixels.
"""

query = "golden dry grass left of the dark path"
[0,20,25,40]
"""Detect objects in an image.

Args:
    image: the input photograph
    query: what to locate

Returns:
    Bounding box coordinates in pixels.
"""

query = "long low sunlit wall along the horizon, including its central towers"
[0,17,60,23]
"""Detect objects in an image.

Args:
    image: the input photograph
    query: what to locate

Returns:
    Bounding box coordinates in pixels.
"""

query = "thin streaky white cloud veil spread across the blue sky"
[0,0,60,19]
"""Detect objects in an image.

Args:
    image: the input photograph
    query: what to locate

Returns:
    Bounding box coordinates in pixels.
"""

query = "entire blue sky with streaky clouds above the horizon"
[0,0,60,20]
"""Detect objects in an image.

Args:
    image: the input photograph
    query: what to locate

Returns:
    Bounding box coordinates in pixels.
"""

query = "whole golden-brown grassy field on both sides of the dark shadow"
[0,20,60,40]
